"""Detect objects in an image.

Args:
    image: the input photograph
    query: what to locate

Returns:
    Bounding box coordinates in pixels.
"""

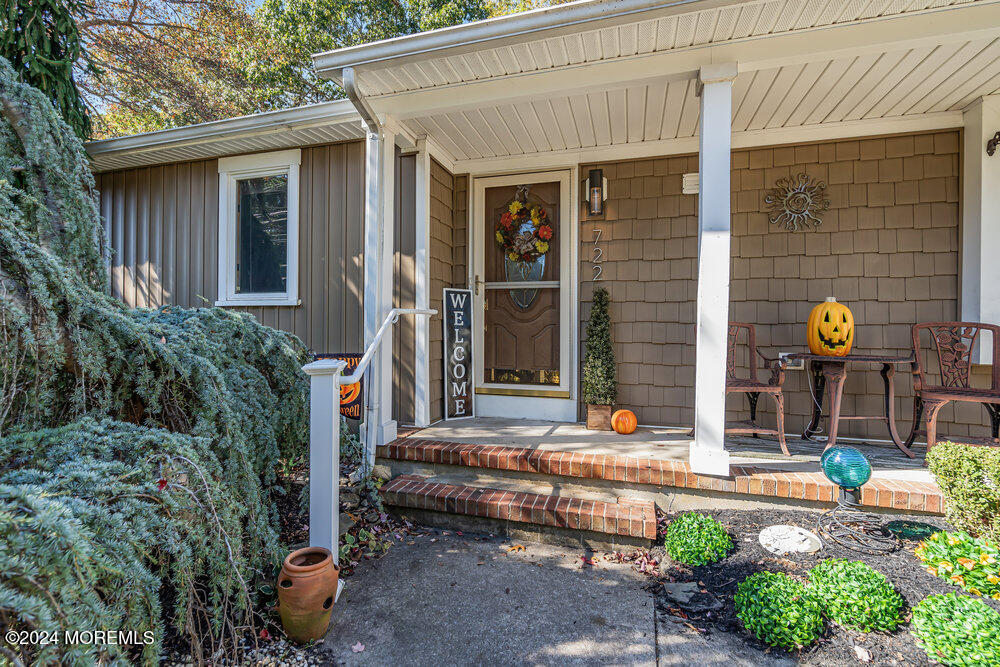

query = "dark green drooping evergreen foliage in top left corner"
[0,0,92,139]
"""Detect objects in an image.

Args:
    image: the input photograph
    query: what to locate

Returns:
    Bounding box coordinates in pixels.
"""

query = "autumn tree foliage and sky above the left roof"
[76,0,572,136]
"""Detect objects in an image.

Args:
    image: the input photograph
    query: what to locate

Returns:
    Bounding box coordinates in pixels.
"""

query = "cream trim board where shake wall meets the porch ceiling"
[453,111,963,176]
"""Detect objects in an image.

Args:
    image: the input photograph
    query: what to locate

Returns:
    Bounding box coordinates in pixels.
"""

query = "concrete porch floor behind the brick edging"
[401,417,933,482]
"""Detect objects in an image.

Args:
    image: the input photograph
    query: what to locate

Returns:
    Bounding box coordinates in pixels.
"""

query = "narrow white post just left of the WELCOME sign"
[413,139,431,426]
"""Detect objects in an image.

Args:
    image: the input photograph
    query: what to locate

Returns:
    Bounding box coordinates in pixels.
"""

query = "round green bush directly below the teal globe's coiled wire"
[809,558,903,632]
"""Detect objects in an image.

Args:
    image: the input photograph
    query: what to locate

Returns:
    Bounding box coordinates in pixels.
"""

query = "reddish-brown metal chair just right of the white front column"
[726,322,790,456]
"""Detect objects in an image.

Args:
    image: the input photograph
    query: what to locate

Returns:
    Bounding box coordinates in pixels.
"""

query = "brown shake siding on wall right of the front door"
[580,131,988,439]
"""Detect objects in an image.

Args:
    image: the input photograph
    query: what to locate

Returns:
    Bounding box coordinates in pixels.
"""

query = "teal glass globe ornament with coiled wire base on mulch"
[816,447,899,554]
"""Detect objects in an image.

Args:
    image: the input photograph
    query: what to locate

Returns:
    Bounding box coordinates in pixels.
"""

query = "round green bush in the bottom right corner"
[910,593,1000,667]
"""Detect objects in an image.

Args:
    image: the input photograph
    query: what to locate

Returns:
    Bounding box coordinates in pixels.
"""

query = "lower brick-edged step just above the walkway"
[379,475,656,540]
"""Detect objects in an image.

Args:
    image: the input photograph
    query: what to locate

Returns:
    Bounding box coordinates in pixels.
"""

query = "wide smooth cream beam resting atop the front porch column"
[368,0,1000,120]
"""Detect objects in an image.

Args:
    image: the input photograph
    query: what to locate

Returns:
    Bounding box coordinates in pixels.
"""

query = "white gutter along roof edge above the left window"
[84,100,361,156]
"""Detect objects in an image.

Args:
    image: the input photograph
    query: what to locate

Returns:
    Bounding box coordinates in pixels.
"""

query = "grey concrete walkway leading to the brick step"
[324,531,782,666]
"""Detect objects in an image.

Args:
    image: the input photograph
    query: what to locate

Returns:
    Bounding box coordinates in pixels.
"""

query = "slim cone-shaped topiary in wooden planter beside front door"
[583,287,618,431]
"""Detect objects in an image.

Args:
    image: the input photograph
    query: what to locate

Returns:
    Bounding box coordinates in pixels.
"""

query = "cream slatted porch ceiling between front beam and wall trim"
[402,36,1000,160]
